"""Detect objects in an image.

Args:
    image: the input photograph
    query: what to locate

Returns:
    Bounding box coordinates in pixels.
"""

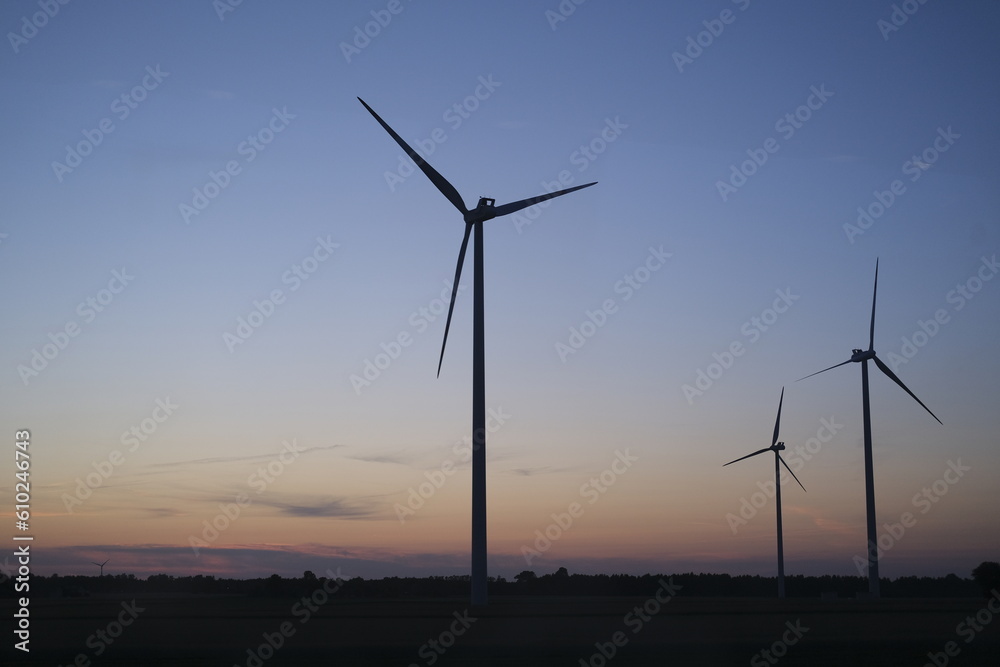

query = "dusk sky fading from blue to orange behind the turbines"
[0,0,1000,577]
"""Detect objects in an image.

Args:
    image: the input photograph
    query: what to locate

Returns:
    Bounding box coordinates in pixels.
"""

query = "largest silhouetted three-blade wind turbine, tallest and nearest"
[358,97,596,605]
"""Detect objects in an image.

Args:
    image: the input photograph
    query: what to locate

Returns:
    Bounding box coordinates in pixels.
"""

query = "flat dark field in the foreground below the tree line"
[2,596,1000,667]
